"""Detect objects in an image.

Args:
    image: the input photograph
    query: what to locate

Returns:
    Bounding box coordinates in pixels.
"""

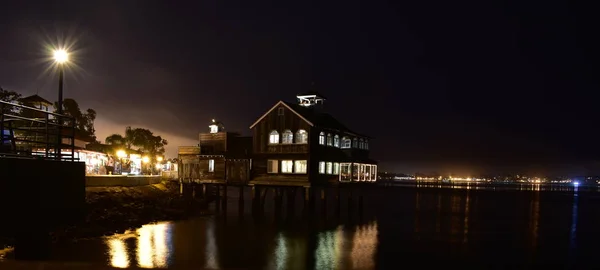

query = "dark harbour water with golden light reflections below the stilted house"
[1,187,600,269]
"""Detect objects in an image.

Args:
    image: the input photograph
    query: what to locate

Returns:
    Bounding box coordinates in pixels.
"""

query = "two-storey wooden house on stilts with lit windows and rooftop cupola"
[250,92,377,186]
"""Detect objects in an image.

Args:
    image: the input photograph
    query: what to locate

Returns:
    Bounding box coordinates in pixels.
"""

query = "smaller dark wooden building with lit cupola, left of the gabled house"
[178,119,252,184]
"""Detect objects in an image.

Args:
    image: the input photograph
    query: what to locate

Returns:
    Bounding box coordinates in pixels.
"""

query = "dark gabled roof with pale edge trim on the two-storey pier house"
[250,101,369,138]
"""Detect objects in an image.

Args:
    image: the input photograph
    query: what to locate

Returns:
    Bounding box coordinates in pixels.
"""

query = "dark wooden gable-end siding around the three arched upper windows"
[253,105,311,153]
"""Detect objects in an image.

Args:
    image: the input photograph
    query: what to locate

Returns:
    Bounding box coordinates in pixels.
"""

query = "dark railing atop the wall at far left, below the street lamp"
[0,100,79,161]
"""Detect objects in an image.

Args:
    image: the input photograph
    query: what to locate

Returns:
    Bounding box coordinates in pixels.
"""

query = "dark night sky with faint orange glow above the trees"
[0,0,600,174]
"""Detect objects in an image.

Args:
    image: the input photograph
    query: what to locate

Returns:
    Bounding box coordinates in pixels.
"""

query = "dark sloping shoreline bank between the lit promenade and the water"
[0,182,213,250]
